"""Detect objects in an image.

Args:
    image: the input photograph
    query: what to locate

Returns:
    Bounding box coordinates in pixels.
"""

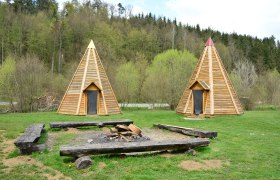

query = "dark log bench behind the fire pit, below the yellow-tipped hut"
[50,120,133,128]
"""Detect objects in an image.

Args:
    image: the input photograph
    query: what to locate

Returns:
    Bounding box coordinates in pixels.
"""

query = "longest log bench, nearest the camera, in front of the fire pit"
[60,138,210,157]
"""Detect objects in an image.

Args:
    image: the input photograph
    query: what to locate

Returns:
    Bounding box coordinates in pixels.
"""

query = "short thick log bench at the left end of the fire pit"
[14,124,45,154]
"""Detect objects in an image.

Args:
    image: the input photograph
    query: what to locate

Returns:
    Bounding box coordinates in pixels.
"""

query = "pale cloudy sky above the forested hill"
[57,0,280,40]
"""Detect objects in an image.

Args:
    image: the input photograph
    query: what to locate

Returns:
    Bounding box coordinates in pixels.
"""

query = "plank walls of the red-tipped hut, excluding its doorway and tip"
[176,46,243,115]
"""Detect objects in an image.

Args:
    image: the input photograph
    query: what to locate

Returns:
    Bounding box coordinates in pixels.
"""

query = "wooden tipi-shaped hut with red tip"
[176,38,243,116]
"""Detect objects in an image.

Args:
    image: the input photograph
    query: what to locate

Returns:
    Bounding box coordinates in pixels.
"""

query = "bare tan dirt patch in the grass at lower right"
[179,159,223,171]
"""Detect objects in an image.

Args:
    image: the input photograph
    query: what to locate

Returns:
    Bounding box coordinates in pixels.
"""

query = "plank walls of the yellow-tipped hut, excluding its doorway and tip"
[58,42,121,115]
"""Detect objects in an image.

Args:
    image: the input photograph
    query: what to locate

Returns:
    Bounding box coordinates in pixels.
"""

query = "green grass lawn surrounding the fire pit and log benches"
[0,110,280,179]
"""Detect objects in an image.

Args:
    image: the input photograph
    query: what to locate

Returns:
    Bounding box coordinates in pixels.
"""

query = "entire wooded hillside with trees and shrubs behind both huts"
[0,0,280,112]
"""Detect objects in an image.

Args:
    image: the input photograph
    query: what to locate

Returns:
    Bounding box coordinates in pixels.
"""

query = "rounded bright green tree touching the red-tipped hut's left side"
[144,50,197,109]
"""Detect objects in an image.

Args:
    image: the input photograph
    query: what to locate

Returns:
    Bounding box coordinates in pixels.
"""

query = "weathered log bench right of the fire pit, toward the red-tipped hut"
[154,124,218,138]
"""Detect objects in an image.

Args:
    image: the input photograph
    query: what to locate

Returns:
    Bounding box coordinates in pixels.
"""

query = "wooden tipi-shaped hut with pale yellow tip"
[58,40,121,115]
